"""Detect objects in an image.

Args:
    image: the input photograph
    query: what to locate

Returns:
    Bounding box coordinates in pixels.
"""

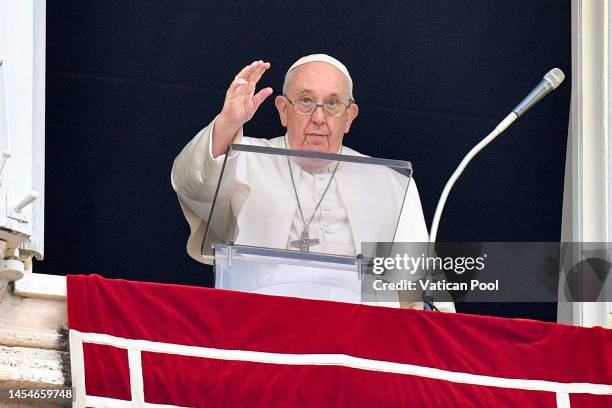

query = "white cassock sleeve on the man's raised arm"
[170,118,242,263]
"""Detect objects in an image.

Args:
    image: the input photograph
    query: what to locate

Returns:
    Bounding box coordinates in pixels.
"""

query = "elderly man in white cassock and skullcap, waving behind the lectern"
[172,54,454,310]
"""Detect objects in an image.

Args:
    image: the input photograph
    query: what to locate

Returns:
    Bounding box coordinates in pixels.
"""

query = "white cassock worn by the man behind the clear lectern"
[172,115,454,312]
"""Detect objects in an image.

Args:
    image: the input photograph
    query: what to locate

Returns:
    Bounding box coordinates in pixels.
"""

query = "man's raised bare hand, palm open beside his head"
[212,61,272,157]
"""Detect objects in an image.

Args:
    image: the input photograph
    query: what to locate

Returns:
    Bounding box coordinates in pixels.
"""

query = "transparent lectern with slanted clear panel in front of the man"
[201,145,412,305]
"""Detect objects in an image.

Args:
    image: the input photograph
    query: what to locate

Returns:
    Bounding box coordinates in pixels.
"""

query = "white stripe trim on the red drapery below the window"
[70,329,612,407]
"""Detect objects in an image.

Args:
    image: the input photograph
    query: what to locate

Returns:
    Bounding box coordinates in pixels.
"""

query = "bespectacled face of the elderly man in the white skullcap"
[275,61,358,153]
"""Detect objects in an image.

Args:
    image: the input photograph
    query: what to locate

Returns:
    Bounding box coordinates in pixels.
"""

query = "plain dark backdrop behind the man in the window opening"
[41,0,571,320]
